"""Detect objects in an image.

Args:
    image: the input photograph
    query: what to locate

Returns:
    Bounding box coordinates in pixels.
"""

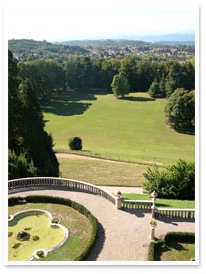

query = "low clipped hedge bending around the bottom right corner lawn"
[147,232,195,261]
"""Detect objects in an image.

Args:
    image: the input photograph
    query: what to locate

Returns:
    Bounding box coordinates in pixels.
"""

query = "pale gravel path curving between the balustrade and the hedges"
[9,187,195,264]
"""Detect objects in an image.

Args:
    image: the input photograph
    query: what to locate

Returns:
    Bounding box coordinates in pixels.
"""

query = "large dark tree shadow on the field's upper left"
[42,93,96,116]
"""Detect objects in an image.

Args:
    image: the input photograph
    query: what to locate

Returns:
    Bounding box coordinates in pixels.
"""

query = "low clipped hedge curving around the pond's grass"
[8,195,97,261]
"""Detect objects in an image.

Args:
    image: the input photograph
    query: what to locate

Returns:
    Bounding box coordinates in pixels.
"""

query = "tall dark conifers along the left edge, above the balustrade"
[8,49,59,179]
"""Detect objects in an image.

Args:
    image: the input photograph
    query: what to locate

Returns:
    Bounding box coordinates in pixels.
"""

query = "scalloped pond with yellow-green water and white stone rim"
[8,209,68,261]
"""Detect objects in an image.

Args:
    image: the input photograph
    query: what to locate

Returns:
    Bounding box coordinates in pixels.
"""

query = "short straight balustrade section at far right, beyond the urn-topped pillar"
[155,208,195,219]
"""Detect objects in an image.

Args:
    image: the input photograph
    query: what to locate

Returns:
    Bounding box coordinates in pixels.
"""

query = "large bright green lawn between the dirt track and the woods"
[42,93,195,165]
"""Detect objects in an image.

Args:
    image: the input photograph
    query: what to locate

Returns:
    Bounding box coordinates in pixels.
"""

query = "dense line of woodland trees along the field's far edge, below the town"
[18,55,195,99]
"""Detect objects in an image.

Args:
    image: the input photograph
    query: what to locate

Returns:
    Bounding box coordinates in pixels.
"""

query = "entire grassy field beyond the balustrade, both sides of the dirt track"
[42,92,195,186]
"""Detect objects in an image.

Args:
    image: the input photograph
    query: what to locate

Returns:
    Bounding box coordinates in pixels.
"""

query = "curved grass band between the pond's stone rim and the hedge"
[9,203,91,261]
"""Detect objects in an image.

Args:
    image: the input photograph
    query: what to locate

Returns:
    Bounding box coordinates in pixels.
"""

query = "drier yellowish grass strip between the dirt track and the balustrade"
[57,154,147,186]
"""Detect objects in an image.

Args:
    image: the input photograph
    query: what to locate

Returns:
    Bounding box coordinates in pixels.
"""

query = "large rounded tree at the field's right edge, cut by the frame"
[164,88,195,133]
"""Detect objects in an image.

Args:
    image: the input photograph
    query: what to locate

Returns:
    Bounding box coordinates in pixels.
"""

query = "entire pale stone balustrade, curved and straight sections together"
[8,177,195,218]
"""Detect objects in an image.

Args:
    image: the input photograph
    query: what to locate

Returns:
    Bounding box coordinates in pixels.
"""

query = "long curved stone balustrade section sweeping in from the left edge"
[8,177,118,207]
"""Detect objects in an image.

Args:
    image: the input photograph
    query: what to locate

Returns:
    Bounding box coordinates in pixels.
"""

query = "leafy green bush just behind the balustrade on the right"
[143,159,195,200]
